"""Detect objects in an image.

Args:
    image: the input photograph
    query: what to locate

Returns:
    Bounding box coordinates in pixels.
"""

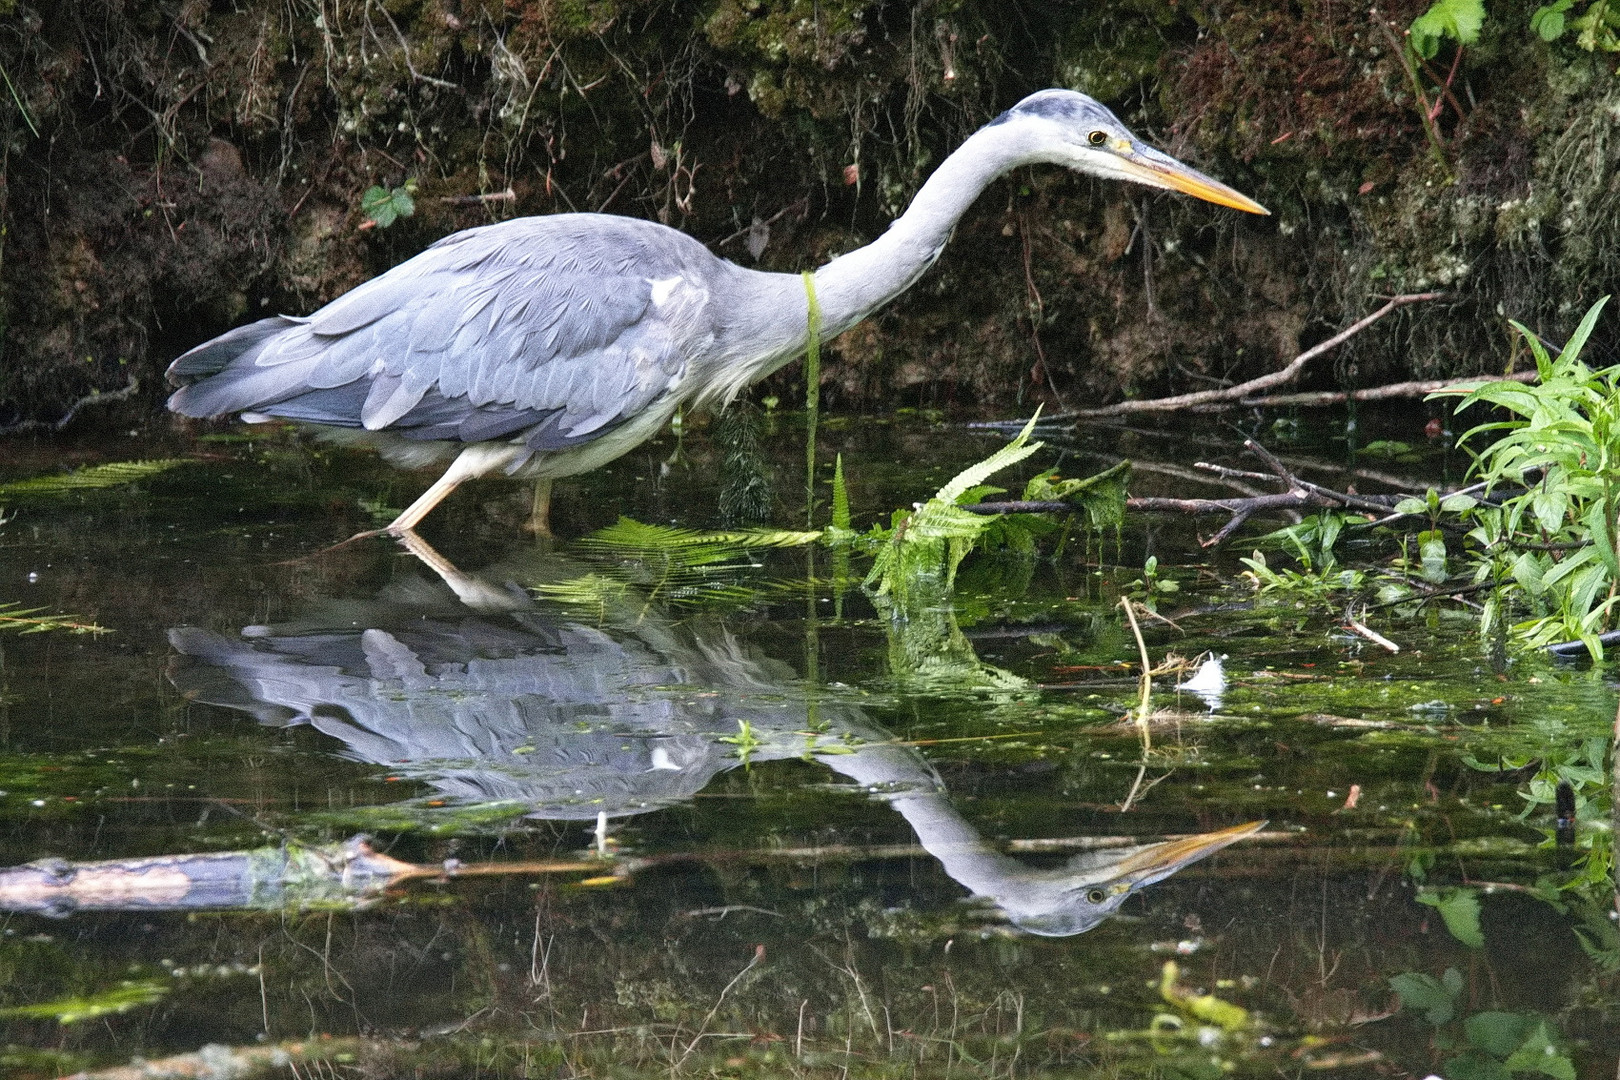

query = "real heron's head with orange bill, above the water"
[990,91,1270,214]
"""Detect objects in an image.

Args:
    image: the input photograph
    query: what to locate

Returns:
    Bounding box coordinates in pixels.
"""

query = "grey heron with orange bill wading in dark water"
[168,89,1267,536]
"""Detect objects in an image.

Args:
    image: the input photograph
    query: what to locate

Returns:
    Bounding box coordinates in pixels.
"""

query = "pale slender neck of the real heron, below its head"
[815,126,1025,337]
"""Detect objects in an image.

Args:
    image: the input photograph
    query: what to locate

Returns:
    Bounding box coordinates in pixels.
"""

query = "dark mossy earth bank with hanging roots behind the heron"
[0,0,1620,426]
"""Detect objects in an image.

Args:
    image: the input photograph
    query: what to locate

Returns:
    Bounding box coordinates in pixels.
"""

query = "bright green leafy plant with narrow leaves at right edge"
[1434,296,1620,657]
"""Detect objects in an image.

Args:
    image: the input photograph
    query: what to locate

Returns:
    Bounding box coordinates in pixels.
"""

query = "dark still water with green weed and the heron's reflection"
[0,418,1620,1080]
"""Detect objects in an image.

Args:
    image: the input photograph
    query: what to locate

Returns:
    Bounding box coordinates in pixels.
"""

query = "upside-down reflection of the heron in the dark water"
[170,549,1260,936]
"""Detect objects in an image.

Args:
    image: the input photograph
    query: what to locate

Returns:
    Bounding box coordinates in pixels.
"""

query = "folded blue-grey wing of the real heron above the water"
[170,215,719,450]
